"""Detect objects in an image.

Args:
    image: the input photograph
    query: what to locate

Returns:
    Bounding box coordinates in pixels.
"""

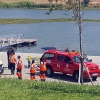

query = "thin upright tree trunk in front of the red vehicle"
[78,0,84,84]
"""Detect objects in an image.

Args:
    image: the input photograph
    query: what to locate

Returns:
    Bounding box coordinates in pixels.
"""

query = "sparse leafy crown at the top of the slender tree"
[47,0,84,19]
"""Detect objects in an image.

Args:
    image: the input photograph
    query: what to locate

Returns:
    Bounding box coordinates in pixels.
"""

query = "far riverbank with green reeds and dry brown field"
[0,0,100,10]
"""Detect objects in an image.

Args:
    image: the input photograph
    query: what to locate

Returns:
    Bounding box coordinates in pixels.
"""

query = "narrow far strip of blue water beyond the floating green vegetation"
[0,9,100,19]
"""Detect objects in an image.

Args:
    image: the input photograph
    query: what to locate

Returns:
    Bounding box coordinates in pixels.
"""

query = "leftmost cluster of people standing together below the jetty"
[7,47,23,79]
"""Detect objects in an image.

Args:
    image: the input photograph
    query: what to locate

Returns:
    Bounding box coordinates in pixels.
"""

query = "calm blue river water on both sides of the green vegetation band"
[0,9,100,56]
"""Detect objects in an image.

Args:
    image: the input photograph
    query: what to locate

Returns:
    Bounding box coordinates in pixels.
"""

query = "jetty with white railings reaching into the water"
[0,34,37,50]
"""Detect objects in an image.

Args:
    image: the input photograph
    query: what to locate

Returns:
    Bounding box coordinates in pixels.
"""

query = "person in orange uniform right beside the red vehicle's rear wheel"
[40,62,46,81]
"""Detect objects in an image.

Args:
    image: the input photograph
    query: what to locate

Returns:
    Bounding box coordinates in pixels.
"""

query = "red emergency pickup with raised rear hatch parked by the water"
[40,49,100,81]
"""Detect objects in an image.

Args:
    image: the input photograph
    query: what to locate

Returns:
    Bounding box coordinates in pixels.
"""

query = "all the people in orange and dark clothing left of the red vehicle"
[7,47,46,81]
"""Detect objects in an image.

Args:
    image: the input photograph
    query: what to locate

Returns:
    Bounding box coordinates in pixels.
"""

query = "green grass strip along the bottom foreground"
[0,78,100,100]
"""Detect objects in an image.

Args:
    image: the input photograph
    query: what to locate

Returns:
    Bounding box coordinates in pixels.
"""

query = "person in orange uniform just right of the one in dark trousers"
[16,56,23,79]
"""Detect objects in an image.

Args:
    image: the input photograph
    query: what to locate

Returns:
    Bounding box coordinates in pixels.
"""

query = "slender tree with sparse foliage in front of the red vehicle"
[49,0,87,84]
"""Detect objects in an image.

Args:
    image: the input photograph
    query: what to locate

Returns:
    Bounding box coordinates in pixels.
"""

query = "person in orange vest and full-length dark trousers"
[9,53,16,75]
